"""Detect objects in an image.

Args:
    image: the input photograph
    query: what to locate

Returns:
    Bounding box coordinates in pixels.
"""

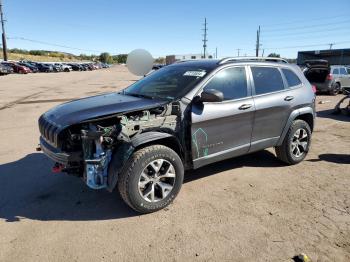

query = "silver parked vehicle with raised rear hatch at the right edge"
[303,60,350,95]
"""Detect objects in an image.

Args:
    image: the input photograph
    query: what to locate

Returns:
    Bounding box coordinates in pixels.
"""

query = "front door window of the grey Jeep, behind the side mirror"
[204,67,248,100]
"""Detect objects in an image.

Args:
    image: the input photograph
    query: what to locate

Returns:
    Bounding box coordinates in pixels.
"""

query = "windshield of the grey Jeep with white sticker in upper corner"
[124,66,208,100]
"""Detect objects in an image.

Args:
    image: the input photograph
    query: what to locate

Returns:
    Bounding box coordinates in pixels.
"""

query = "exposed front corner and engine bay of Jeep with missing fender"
[43,103,180,190]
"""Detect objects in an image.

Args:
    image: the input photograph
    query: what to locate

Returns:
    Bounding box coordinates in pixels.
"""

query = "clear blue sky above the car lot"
[2,0,350,58]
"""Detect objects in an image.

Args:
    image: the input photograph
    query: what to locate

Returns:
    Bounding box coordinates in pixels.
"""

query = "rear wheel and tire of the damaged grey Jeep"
[275,120,311,165]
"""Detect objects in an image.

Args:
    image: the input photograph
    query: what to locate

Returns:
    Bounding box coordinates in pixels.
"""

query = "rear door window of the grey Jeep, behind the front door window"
[251,67,284,95]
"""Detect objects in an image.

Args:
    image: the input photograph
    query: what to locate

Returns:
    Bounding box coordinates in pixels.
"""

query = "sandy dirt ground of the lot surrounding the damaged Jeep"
[0,66,350,261]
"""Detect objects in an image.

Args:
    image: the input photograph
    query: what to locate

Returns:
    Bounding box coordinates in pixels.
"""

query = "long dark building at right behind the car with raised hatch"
[297,48,350,65]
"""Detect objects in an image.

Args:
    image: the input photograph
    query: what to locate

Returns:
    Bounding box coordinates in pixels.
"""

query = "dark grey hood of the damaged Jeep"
[43,93,167,129]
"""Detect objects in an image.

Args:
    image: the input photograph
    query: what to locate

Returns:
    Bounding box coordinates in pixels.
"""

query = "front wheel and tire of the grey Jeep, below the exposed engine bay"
[118,145,184,213]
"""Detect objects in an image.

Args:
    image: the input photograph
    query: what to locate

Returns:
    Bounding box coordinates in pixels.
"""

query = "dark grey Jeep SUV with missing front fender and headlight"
[39,58,315,213]
